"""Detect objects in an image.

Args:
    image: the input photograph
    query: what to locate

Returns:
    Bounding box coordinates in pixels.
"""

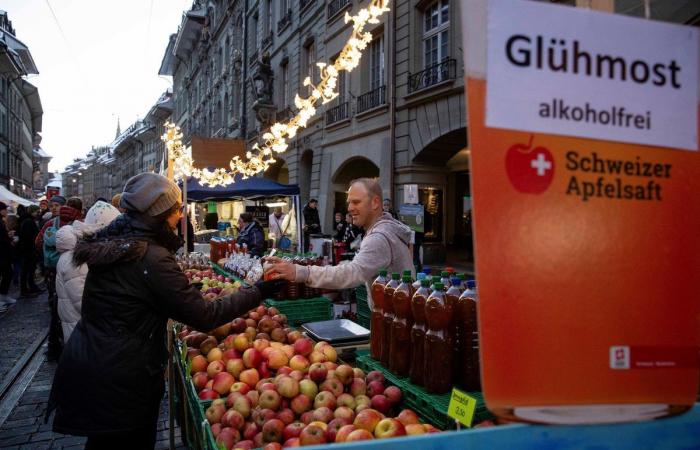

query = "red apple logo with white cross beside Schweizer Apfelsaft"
[506,135,554,194]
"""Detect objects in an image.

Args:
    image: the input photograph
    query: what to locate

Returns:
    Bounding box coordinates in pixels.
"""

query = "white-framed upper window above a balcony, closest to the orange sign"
[423,0,450,68]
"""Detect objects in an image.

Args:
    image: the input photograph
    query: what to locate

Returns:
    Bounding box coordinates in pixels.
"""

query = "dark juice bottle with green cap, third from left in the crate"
[389,275,413,377]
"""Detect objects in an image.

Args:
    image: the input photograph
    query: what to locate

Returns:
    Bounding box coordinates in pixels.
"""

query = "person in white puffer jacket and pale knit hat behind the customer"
[56,201,120,342]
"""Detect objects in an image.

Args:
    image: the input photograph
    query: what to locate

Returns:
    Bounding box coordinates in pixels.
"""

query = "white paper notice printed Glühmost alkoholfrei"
[486,0,698,151]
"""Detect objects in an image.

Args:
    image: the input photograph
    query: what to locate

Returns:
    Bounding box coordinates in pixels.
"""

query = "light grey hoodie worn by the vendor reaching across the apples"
[296,213,414,304]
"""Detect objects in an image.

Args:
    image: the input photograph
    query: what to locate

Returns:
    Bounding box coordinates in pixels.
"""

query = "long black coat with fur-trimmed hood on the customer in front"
[48,214,260,436]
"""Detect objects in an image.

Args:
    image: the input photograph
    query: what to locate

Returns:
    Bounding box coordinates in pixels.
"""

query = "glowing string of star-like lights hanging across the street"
[162,0,389,187]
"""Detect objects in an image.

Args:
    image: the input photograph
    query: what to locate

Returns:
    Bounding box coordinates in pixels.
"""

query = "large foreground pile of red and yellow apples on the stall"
[180,306,439,450]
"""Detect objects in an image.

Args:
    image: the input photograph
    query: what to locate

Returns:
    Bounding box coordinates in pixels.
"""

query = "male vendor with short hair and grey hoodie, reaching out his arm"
[269,178,413,306]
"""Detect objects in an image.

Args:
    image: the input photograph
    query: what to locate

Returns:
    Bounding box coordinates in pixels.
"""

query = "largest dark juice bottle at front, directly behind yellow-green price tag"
[423,282,452,394]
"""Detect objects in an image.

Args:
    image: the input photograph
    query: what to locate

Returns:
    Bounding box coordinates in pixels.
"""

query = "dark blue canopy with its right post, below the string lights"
[180,175,301,248]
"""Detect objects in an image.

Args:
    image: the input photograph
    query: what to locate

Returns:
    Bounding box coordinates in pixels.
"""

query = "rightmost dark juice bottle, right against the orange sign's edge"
[455,280,481,391]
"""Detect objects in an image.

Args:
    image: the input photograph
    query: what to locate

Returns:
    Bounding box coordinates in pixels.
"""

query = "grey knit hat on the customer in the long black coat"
[119,172,182,217]
